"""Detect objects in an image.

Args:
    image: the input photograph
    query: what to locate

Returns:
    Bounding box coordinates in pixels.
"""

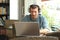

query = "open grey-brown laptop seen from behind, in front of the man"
[14,22,39,36]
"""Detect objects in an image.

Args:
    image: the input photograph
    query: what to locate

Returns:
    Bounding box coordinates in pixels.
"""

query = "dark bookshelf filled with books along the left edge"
[0,0,10,27]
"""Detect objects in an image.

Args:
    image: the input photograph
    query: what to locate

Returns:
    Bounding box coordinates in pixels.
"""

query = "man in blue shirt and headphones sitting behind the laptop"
[22,4,50,34]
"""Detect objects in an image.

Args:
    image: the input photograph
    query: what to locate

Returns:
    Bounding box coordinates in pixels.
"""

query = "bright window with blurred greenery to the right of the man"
[41,0,60,30]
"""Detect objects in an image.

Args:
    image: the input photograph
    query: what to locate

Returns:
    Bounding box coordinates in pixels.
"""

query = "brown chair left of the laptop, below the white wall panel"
[5,20,18,38]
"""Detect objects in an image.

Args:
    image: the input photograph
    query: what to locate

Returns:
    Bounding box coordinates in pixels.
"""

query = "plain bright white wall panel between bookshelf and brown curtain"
[10,0,18,20]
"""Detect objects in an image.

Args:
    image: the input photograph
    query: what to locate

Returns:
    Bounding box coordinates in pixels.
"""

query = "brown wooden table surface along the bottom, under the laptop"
[10,36,58,40]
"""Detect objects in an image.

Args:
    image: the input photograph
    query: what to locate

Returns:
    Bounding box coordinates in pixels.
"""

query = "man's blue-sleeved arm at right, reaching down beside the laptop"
[40,17,51,34]
